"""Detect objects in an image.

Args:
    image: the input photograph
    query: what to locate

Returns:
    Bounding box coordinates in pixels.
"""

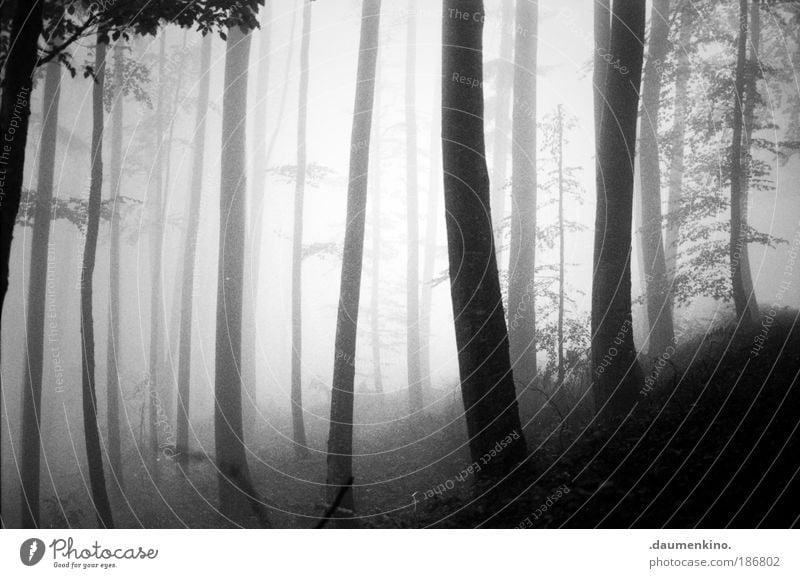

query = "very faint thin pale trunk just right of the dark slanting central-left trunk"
[369,64,383,393]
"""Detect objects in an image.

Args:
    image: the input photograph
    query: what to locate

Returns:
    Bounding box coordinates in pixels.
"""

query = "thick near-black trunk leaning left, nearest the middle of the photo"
[442,0,526,478]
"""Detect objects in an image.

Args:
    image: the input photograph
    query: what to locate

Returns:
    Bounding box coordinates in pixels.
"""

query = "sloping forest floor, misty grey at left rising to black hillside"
[43,311,800,528]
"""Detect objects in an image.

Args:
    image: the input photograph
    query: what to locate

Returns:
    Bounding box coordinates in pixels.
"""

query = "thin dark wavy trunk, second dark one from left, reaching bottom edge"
[81,34,114,528]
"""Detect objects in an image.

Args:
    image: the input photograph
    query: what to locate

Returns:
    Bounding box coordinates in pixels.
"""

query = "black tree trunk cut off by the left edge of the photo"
[0,2,44,527]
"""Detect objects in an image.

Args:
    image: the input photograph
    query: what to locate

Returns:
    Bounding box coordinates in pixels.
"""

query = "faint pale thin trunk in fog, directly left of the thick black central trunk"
[420,74,442,392]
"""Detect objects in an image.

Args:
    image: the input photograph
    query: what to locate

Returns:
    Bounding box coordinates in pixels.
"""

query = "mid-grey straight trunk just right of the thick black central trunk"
[508,0,539,391]
